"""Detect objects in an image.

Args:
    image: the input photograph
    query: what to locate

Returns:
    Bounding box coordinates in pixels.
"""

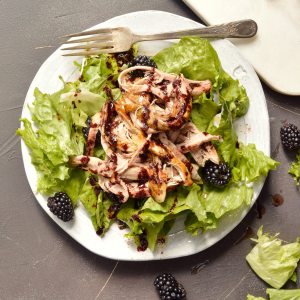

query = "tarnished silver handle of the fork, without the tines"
[133,19,257,43]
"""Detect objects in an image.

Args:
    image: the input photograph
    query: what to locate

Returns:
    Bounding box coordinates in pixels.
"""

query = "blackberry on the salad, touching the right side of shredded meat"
[202,160,231,187]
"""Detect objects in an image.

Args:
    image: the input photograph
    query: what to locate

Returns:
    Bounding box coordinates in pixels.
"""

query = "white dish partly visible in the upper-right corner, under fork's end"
[183,0,300,96]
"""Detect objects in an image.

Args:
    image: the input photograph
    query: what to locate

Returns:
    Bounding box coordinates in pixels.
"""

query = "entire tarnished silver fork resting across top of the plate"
[61,19,257,56]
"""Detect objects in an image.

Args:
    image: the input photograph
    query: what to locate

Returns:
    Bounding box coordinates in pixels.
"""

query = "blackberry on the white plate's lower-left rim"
[47,192,74,222]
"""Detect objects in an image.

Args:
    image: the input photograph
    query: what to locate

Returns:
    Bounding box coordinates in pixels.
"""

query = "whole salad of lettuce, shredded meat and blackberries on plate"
[17,37,278,251]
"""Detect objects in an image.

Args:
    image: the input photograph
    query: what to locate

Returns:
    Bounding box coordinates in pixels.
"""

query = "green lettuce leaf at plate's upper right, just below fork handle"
[153,37,249,118]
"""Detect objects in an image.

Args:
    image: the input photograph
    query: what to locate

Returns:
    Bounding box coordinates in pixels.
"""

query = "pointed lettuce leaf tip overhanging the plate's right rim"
[232,143,279,182]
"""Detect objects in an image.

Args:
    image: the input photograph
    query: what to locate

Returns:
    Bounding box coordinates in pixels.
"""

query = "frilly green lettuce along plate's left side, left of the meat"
[17,54,121,204]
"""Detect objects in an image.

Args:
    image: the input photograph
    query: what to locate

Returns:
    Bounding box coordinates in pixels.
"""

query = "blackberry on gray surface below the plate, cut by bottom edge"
[153,273,186,300]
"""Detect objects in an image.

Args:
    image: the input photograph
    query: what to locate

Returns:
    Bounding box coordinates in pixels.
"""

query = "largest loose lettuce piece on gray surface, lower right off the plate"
[246,227,300,289]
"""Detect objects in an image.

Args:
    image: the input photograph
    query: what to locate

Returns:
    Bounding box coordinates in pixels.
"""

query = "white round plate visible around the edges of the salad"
[22,11,270,261]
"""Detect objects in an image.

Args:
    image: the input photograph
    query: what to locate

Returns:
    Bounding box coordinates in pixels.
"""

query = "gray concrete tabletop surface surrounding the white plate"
[0,0,300,300]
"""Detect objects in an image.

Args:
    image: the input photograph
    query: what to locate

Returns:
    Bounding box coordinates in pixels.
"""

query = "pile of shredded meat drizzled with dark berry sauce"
[70,66,220,202]
